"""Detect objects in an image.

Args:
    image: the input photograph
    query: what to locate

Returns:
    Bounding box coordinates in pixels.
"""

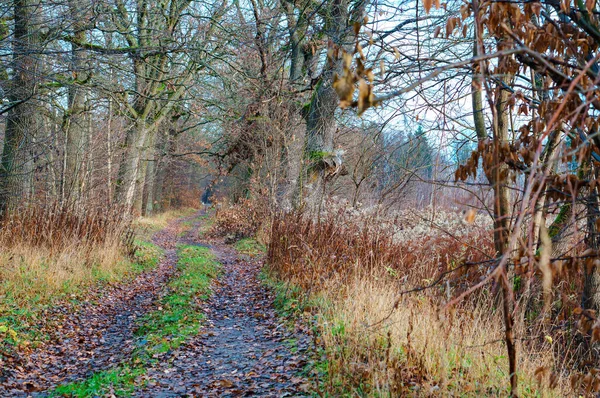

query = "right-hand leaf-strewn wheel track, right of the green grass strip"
[135,233,309,397]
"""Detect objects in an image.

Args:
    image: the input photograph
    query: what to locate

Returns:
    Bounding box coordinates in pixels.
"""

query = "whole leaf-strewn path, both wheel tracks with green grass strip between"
[0,213,308,397]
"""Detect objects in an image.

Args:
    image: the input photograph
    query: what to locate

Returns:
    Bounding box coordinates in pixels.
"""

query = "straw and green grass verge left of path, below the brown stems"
[0,210,192,374]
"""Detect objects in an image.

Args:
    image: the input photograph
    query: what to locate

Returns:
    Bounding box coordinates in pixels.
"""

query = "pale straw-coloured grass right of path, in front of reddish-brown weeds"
[310,277,568,397]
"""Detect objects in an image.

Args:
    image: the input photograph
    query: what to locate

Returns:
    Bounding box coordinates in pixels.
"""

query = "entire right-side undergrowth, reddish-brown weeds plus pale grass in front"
[267,207,576,397]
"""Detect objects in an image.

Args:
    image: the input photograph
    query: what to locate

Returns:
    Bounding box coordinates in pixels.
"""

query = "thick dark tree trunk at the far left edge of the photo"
[0,0,41,213]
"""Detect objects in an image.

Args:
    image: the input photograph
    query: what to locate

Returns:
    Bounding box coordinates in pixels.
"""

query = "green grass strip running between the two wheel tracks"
[53,246,219,397]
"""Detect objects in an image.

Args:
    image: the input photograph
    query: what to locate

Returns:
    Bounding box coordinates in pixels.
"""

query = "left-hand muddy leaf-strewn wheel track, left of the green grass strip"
[0,211,198,398]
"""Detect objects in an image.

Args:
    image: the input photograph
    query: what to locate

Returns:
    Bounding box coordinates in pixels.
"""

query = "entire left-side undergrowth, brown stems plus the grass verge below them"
[0,207,189,364]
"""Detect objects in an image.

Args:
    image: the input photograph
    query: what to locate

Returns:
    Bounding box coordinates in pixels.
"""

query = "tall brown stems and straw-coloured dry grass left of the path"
[0,205,134,304]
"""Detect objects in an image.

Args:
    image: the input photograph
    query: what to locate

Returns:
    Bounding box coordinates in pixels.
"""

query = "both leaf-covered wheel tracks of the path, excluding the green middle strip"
[0,215,308,398]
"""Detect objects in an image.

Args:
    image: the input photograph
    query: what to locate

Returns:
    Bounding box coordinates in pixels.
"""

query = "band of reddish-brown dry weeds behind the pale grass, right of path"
[268,211,493,289]
